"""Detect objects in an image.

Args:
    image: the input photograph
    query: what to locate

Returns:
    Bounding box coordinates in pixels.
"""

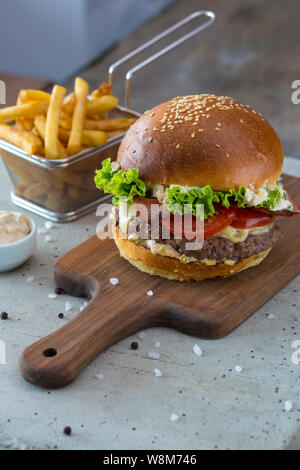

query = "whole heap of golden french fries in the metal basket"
[0,78,122,161]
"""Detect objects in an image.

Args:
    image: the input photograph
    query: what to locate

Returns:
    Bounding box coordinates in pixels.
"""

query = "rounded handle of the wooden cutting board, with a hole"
[19,294,159,388]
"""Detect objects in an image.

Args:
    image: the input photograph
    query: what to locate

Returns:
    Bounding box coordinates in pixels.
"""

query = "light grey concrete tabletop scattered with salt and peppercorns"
[0,159,300,449]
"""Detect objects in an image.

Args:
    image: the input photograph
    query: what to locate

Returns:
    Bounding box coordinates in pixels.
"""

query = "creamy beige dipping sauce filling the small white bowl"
[0,211,31,245]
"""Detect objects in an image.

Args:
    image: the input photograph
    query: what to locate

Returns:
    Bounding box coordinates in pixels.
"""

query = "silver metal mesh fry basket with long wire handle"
[0,11,215,222]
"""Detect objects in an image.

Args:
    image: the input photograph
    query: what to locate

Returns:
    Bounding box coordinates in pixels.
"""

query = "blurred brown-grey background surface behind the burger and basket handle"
[68,0,300,158]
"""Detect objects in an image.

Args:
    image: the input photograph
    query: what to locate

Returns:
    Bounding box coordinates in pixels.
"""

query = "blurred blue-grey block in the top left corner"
[0,0,173,81]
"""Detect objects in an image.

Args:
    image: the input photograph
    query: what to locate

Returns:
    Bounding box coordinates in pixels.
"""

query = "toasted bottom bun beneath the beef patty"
[112,226,272,281]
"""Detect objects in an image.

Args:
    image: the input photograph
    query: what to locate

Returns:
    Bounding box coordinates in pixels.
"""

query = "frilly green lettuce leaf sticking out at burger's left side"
[95,158,147,206]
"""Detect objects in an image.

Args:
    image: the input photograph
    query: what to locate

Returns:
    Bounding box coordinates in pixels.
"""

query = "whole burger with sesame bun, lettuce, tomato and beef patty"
[95,94,299,281]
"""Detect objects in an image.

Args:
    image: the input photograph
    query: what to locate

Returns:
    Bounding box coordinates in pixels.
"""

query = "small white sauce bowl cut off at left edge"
[0,211,36,273]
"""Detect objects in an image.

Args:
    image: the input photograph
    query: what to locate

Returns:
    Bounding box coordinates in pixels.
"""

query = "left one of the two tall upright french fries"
[45,85,66,159]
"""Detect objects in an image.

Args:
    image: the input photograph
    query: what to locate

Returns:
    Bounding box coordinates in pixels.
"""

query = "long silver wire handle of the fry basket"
[108,10,216,106]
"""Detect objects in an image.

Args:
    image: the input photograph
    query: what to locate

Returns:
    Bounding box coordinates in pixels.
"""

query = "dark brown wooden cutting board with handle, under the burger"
[20,176,300,388]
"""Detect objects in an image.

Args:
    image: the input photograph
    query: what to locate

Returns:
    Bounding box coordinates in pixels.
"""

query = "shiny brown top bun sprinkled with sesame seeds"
[118,94,284,191]
